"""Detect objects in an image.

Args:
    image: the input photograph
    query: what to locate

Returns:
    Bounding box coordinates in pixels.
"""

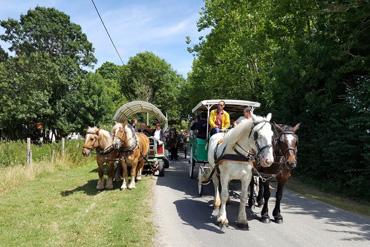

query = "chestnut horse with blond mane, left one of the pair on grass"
[82,127,119,190]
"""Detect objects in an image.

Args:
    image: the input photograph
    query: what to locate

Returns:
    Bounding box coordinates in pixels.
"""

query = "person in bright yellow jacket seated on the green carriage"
[209,100,230,135]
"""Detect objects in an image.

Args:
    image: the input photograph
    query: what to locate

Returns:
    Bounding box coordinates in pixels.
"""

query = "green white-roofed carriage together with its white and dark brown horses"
[189,100,300,229]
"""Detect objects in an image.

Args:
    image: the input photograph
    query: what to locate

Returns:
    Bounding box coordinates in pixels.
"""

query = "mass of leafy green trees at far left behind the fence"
[0,7,114,139]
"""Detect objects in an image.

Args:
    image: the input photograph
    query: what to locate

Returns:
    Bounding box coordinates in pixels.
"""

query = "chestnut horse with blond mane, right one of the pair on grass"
[112,123,149,189]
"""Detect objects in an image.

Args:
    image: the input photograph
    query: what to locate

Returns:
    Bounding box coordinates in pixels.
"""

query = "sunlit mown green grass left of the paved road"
[0,161,154,246]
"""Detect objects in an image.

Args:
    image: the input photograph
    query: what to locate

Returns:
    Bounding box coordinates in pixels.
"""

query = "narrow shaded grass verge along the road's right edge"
[287,178,370,216]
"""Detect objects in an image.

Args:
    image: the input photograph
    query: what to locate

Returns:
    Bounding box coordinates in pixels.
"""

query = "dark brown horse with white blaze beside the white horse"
[248,123,300,223]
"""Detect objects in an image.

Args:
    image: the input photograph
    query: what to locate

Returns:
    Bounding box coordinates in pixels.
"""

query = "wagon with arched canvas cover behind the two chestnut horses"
[113,101,169,176]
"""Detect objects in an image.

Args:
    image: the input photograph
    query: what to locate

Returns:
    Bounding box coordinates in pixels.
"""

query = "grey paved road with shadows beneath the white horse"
[154,156,370,247]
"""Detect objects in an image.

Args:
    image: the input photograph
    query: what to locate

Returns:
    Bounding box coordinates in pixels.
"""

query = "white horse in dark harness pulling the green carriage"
[208,113,274,229]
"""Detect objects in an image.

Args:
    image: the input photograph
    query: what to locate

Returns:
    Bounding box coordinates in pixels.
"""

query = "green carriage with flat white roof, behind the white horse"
[189,100,261,195]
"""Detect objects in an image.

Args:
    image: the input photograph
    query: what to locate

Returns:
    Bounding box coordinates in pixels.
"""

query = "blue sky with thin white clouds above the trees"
[0,0,204,77]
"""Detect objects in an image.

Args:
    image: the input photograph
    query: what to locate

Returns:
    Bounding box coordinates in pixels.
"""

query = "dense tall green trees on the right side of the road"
[188,0,370,199]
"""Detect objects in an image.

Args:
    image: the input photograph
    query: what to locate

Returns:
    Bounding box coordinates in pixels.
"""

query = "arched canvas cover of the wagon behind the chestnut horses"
[113,100,167,125]
